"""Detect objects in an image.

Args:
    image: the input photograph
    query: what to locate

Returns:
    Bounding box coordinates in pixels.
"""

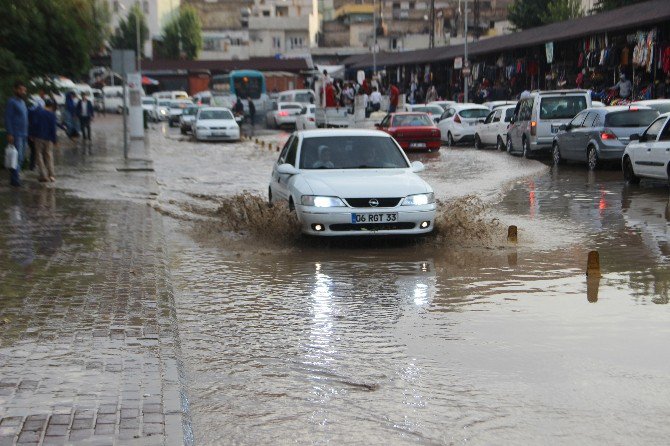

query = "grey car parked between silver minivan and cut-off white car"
[552,106,658,170]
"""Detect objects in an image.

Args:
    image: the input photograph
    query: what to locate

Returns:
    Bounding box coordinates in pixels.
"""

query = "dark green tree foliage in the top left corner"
[0,0,105,77]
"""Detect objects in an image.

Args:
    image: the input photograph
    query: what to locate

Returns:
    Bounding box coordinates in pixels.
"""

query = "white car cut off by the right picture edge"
[622,113,670,184]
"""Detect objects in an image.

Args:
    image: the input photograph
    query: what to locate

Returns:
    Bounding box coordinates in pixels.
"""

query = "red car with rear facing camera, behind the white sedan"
[376,113,442,151]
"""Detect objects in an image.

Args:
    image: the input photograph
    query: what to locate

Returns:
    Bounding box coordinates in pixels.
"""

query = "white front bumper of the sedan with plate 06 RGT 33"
[296,203,437,237]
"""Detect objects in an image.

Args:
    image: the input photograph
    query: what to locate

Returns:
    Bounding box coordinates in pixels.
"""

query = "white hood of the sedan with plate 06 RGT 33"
[301,169,432,198]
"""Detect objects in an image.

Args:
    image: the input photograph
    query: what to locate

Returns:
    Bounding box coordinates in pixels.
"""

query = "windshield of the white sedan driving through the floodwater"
[300,136,409,169]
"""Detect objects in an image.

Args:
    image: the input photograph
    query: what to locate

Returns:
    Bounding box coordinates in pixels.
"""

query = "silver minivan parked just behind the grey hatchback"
[506,90,591,157]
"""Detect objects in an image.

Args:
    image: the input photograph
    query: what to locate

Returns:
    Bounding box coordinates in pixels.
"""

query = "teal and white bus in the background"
[210,70,269,112]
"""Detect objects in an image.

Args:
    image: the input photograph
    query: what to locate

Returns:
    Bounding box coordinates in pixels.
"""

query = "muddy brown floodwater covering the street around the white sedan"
[151,125,670,445]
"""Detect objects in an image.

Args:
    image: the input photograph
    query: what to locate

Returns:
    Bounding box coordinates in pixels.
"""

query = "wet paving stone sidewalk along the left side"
[0,116,189,446]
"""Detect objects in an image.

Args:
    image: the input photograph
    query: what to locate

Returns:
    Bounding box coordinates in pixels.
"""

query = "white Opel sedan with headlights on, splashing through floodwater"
[269,129,436,236]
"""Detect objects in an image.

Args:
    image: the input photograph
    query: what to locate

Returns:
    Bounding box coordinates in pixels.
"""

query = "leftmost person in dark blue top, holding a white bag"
[5,81,28,187]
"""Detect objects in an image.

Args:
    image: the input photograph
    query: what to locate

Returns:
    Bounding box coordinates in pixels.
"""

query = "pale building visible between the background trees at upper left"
[107,0,181,57]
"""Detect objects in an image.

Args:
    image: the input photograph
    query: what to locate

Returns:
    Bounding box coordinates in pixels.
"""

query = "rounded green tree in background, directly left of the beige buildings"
[162,5,203,60]
